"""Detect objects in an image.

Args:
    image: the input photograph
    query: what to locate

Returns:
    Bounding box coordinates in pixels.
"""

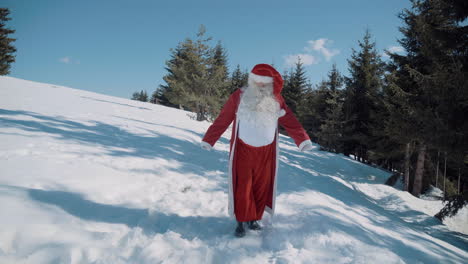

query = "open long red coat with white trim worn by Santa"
[202,89,312,217]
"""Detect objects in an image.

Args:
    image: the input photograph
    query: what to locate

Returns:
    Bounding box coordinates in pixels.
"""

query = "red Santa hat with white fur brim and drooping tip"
[249,63,283,102]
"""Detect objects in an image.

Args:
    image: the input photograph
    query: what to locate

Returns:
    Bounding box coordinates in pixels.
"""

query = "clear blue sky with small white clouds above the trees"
[1,0,410,98]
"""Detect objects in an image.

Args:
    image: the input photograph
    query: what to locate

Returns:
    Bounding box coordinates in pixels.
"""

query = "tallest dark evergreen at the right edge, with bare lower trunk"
[388,0,468,196]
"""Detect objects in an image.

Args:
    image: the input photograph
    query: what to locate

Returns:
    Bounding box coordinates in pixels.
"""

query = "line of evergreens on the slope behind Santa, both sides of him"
[133,0,468,213]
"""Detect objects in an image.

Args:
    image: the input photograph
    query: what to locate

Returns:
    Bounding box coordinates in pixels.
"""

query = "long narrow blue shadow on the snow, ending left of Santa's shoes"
[25,189,234,240]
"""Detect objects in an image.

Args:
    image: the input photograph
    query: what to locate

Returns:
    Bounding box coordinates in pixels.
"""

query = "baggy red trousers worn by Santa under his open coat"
[234,138,275,222]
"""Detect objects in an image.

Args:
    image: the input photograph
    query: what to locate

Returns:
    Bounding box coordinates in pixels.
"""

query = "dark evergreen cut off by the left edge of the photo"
[0,8,16,75]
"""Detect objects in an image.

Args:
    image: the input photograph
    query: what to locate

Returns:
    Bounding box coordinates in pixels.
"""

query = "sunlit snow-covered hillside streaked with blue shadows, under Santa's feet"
[0,77,468,263]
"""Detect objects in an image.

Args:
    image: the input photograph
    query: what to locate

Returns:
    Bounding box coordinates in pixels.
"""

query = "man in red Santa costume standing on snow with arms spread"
[201,64,312,237]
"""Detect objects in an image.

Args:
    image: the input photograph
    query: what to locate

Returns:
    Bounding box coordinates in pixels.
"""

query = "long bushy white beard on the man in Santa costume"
[237,82,280,126]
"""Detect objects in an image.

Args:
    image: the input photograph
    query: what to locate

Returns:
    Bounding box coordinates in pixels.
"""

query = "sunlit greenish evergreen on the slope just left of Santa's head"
[163,26,226,121]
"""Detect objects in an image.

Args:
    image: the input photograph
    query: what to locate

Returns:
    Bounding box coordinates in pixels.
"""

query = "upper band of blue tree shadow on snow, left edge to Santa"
[0,109,229,188]
